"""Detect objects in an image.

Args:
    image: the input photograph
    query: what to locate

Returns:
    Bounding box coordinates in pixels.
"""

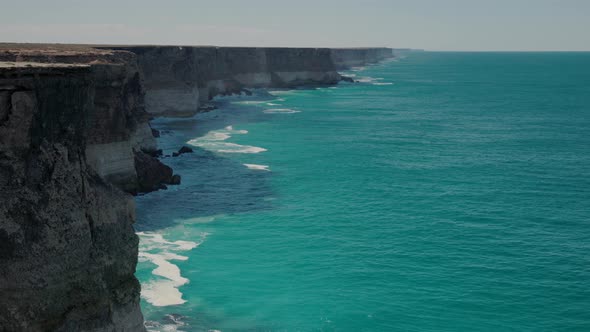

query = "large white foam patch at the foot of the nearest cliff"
[137,232,207,307]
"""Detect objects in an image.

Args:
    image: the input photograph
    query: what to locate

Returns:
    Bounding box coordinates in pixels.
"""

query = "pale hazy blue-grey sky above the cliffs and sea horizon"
[0,0,590,50]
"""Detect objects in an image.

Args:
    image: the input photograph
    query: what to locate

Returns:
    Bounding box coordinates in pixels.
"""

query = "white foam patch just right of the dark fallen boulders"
[187,126,266,153]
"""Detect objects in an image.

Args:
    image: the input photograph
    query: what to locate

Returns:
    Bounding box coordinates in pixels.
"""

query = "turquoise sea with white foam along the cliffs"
[136,53,590,332]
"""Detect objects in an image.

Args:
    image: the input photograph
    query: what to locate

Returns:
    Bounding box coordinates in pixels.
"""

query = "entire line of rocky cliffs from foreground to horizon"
[0,44,392,331]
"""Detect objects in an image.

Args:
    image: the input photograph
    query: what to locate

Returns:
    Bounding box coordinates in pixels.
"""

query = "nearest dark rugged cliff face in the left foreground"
[0,62,144,331]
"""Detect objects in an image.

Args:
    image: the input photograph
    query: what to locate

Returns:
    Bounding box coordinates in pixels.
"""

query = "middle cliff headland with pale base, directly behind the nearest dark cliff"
[0,45,180,193]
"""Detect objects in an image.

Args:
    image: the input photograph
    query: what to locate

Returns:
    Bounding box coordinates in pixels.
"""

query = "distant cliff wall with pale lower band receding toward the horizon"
[107,46,392,116]
